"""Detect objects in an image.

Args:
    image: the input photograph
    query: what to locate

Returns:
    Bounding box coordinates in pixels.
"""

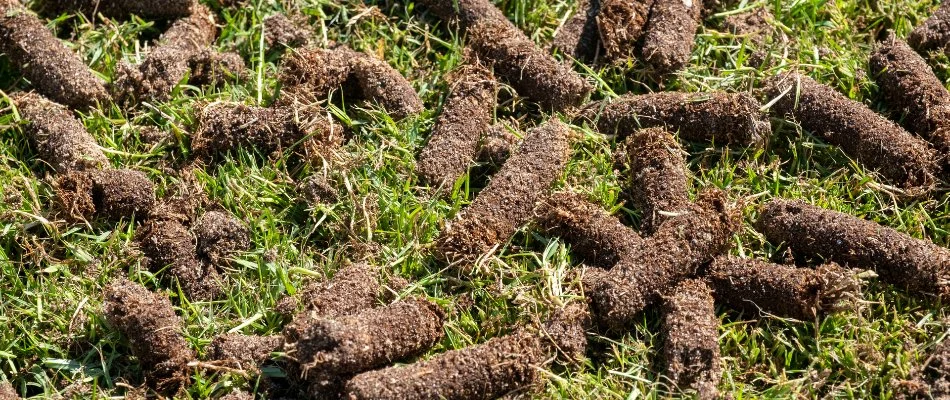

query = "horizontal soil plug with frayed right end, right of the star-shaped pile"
[706,256,861,321]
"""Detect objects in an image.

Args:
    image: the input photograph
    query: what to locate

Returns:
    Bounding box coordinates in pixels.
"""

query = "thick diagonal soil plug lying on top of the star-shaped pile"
[583,191,739,330]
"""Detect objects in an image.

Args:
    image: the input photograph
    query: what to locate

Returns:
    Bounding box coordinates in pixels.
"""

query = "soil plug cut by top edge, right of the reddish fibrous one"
[640,0,703,74]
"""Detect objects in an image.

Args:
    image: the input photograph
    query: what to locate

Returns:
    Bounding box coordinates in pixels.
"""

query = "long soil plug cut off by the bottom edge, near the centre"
[346,331,545,400]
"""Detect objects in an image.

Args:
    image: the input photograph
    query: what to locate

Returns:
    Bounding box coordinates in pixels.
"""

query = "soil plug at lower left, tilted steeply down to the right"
[103,278,195,394]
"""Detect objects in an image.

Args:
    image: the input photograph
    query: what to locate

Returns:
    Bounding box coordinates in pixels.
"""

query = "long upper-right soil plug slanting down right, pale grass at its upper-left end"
[766,73,936,195]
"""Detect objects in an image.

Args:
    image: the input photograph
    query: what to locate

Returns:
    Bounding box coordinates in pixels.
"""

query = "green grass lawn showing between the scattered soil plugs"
[0,0,950,399]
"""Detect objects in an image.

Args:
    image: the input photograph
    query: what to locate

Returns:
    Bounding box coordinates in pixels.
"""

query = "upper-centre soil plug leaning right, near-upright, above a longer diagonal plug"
[416,62,498,190]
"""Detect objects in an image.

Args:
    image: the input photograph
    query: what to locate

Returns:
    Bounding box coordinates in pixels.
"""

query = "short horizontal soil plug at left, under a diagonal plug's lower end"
[54,169,155,220]
